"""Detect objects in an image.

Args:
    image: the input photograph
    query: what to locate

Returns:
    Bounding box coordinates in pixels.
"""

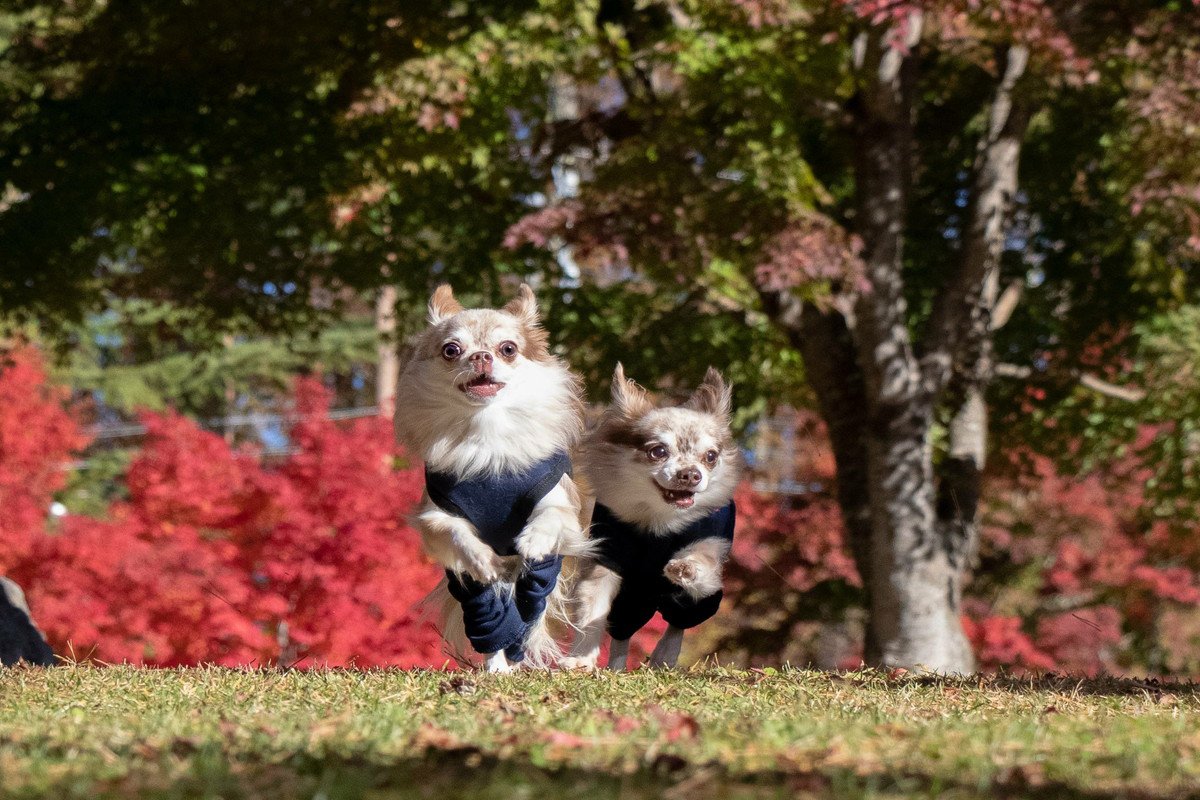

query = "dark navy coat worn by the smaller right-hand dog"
[590,501,737,640]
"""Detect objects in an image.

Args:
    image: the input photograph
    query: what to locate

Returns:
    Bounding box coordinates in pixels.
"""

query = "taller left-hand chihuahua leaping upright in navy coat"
[396,284,587,672]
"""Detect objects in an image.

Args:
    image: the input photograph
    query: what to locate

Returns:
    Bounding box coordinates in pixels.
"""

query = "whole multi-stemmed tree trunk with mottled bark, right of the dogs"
[762,32,1031,673]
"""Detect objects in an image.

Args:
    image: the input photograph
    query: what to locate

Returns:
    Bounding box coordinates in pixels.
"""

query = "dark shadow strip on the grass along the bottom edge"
[16,748,1200,800]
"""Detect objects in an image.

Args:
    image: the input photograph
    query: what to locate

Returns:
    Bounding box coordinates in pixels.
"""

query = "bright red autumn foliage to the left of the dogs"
[0,351,445,667]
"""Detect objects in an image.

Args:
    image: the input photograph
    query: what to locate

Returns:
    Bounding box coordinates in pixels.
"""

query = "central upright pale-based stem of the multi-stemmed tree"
[840,12,974,673]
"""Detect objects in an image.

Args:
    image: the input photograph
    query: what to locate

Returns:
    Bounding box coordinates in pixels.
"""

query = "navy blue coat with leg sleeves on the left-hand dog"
[425,452,571,661]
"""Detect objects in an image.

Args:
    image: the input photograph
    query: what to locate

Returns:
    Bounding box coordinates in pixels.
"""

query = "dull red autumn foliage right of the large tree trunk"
[967,456,1200,674]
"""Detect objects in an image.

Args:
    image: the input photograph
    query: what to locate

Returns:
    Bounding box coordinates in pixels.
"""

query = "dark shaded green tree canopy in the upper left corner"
[0,0,535,327]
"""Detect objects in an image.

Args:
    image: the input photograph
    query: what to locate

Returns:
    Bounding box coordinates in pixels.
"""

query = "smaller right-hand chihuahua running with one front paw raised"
[562,365,743,669]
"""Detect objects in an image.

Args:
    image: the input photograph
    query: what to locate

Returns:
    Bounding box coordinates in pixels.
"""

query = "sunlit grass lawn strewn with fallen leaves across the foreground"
[0,667,1200,800]
